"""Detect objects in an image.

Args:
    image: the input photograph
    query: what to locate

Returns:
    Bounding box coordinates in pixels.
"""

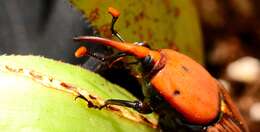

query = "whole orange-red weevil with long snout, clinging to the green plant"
[74,8,248,132]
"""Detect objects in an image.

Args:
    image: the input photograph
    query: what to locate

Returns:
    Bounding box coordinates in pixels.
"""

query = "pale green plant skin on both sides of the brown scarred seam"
[0,56,157,132]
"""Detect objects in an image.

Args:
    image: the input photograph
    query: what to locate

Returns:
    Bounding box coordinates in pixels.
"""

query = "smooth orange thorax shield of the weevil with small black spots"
[151,49,220,125]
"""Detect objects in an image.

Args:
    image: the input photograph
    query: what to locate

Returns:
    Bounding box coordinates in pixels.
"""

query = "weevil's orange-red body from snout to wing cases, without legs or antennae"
[75,36,248,132]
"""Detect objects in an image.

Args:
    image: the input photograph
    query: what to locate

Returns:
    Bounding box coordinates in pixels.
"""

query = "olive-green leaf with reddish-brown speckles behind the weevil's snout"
[70,0,203,63]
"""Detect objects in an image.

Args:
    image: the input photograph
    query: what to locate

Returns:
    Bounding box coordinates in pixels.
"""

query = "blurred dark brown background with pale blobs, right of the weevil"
[194,0,260,132]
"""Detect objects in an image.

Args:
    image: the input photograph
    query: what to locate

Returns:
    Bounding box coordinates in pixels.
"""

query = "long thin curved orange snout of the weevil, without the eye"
[74,36,160,62]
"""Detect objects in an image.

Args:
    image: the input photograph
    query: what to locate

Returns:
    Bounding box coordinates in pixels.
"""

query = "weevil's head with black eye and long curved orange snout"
[74,36,161,71]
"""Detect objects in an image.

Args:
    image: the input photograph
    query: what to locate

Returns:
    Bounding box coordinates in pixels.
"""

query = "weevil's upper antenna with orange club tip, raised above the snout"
[108,7,125,42]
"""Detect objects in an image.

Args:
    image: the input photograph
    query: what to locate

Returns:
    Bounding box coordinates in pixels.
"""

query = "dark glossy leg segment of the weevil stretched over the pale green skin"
[101,99,153,114]
